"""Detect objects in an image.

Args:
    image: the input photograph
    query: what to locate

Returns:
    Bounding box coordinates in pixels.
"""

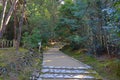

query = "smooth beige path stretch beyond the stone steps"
[43,48,91,67]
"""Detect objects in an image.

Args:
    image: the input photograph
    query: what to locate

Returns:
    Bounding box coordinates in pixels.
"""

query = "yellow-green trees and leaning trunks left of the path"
[0,0,59,49]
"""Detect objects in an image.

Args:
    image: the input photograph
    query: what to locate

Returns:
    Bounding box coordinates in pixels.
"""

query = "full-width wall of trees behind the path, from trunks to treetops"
[0,0,120,55]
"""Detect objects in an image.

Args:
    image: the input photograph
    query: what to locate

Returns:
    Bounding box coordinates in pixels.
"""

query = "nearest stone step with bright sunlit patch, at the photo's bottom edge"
[40,74,95,80]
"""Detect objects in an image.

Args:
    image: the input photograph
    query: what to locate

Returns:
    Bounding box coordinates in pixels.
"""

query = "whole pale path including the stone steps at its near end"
[38,48,102,80]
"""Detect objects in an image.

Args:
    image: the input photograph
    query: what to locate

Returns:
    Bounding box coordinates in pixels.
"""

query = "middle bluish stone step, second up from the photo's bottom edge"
[41,68,96,74]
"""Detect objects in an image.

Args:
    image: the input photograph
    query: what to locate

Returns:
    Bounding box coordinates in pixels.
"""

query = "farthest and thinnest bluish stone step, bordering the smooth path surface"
[43,66,92,70]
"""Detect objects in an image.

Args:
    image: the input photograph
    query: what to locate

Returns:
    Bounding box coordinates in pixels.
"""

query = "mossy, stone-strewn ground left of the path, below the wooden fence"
[0,48,42,80]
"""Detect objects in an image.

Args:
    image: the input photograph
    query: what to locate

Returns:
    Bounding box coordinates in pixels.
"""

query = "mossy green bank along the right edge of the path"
[61,46,120,80]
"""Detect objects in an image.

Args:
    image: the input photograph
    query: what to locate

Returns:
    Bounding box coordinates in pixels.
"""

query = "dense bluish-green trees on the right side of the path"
[56,0,119,55]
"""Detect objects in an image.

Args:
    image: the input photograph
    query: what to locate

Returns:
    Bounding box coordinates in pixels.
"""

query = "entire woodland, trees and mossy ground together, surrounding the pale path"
[0,0,120,80]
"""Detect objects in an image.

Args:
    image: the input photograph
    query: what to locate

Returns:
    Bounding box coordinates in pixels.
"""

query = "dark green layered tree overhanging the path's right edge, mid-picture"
[56,0,88,49]
